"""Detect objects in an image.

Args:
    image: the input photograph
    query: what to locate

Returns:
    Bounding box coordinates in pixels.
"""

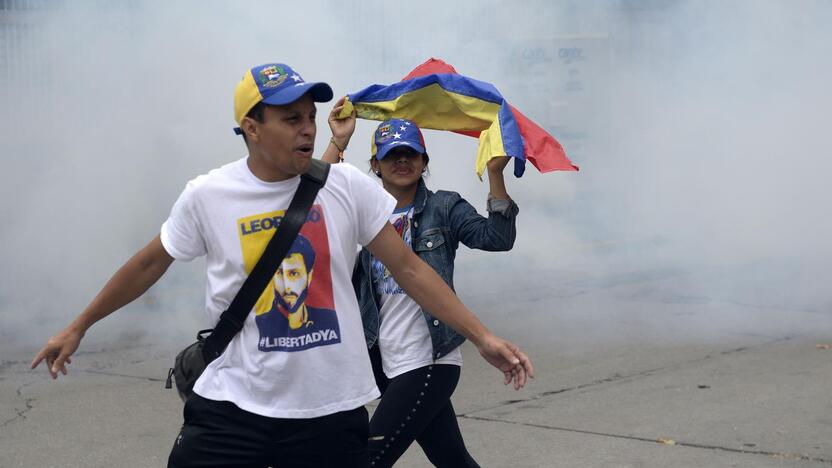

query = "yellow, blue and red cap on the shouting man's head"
[234,63,332,135]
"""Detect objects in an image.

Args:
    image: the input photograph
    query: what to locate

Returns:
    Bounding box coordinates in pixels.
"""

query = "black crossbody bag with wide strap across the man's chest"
[165,159,330,401]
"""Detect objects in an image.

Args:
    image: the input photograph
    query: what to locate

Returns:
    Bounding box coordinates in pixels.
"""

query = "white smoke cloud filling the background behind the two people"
[0,0,832,349]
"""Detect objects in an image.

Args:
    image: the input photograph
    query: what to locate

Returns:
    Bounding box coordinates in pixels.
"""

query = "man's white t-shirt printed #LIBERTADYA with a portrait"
[161,158,395,418]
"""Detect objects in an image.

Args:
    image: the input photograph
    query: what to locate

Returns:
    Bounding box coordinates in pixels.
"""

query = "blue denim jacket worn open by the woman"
[352,179,519,359]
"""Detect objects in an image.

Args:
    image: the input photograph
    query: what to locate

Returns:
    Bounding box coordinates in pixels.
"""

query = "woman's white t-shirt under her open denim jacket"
[370,205,462,379]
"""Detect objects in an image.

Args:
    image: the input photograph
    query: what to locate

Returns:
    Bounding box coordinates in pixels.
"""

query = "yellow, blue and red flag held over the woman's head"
[341,58,578,177]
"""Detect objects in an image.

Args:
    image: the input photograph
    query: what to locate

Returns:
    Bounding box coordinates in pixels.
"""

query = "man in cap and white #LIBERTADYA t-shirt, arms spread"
[32,63,534,467]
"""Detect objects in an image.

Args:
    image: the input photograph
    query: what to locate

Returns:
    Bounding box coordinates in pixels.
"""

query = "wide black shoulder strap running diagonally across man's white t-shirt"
[203,159,330,362]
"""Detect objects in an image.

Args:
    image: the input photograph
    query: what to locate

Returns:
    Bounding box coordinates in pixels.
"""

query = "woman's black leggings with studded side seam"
[369,345,479,468]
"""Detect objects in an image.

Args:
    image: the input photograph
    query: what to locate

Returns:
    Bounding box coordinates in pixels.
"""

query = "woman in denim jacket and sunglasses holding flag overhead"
[324,110,518,468]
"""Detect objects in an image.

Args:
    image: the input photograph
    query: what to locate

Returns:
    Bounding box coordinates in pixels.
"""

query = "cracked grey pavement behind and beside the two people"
[0,266,832,468]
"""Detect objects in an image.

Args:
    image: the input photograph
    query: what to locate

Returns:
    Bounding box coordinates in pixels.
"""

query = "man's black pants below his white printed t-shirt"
[168,394,368,468]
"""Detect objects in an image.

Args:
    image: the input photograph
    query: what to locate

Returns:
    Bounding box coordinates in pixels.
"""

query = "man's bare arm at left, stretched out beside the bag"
[32,235,173,379]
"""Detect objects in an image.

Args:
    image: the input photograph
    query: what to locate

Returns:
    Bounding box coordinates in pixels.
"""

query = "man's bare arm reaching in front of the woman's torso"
[367,223,534,389]
